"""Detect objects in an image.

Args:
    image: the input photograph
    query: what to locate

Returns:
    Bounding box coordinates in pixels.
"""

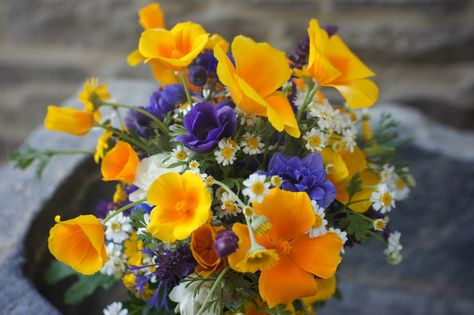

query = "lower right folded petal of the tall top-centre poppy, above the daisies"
[265,91,301,138]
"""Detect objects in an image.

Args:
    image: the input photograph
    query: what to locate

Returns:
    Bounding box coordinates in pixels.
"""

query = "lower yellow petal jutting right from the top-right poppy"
[327,79,379,109]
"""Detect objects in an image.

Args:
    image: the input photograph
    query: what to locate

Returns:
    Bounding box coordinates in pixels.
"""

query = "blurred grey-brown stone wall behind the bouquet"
[0,0,474,160]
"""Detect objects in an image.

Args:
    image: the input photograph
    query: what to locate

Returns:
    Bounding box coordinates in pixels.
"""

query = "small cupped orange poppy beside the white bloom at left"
[101,141,140,184]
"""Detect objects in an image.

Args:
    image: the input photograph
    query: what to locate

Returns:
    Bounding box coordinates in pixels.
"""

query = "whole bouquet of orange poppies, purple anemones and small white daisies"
[12,3,414,315]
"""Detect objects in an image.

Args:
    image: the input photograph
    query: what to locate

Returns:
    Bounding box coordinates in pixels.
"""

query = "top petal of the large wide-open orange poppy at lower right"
[253,188,315,241]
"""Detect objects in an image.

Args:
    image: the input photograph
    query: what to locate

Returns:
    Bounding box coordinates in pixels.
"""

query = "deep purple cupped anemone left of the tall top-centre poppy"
[176,102,237,153]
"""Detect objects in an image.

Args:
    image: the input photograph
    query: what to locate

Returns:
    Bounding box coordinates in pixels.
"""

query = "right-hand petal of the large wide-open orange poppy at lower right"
[289,232,342,278]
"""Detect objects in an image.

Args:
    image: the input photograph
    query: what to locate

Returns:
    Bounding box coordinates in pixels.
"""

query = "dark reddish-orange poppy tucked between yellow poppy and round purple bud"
[191,224,224,278]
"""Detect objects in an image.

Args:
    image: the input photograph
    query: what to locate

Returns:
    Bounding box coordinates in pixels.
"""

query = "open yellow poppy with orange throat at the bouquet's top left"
[138,22,209,69]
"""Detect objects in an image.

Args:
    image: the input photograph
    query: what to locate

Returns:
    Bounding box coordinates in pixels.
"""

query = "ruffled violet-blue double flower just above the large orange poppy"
[268,153,336,208]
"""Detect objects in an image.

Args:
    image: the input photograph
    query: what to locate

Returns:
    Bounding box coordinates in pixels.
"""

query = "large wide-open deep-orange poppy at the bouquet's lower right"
[229,188,342,307]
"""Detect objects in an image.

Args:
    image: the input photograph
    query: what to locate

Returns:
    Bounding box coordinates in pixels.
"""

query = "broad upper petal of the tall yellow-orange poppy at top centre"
[232,35,291,97]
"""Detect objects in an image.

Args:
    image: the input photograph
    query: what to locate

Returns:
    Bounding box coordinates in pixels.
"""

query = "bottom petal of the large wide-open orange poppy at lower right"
[258,257,318,307]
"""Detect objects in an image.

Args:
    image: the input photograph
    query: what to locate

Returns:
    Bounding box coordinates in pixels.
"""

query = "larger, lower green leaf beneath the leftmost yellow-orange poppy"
[64,273,117,305]
